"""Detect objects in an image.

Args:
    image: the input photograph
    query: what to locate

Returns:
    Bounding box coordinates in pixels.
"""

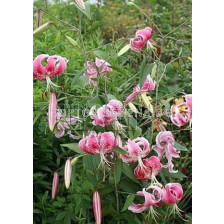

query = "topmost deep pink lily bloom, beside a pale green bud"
[130,27,152,53]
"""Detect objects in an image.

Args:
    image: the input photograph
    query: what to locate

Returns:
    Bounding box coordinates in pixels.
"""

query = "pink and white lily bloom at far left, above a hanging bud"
[33,54,68,89]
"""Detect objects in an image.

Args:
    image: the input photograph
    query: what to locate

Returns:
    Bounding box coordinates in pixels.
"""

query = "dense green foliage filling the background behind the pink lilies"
[33,0,191,224]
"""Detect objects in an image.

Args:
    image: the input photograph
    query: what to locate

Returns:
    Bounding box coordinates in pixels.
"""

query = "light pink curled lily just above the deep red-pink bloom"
[120,137,150,164]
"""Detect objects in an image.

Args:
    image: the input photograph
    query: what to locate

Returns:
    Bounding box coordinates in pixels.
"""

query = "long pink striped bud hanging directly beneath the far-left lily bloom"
[48,92,57,131]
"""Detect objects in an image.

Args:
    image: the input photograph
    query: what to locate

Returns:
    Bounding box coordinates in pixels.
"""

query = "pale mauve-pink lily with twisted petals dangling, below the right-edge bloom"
[154,131,180,173]
